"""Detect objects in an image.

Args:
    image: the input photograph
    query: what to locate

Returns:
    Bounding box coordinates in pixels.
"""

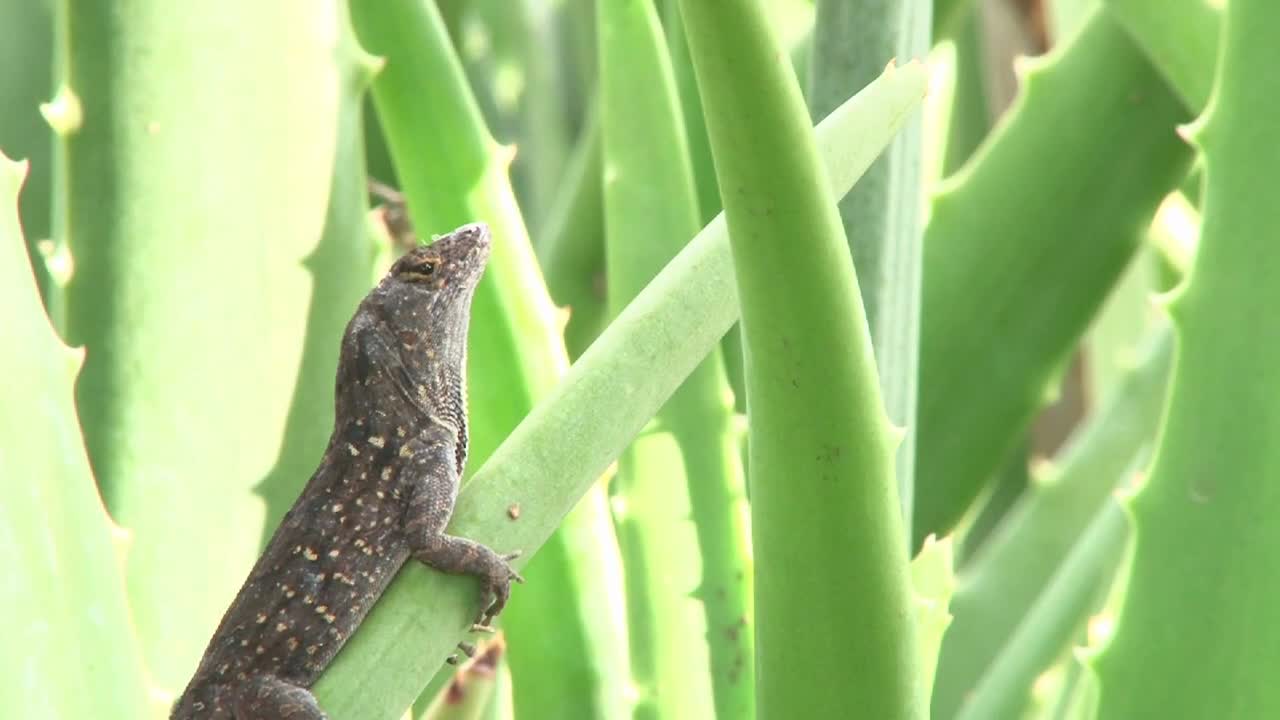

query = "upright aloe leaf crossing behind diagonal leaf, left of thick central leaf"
[596,0,754,717]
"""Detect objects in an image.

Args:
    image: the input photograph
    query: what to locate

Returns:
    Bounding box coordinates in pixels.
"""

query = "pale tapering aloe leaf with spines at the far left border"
[0,154,150,720]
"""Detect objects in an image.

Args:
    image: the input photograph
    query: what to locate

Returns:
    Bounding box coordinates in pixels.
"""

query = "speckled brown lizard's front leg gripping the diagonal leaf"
[403,428,525,626]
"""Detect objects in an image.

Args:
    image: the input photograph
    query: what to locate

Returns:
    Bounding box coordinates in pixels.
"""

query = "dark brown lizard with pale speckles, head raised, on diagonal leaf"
[170,223,524,720]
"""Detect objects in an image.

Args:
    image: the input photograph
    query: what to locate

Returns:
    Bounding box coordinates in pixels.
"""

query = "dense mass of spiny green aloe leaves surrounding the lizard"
[0,0,1280,720]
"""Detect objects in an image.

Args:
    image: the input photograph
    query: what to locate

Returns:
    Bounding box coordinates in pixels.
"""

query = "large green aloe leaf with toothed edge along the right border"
[1093,0,1280,717]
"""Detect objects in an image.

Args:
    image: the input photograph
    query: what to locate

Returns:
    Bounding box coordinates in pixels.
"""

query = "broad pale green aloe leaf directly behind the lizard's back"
[56,0,367,693]
